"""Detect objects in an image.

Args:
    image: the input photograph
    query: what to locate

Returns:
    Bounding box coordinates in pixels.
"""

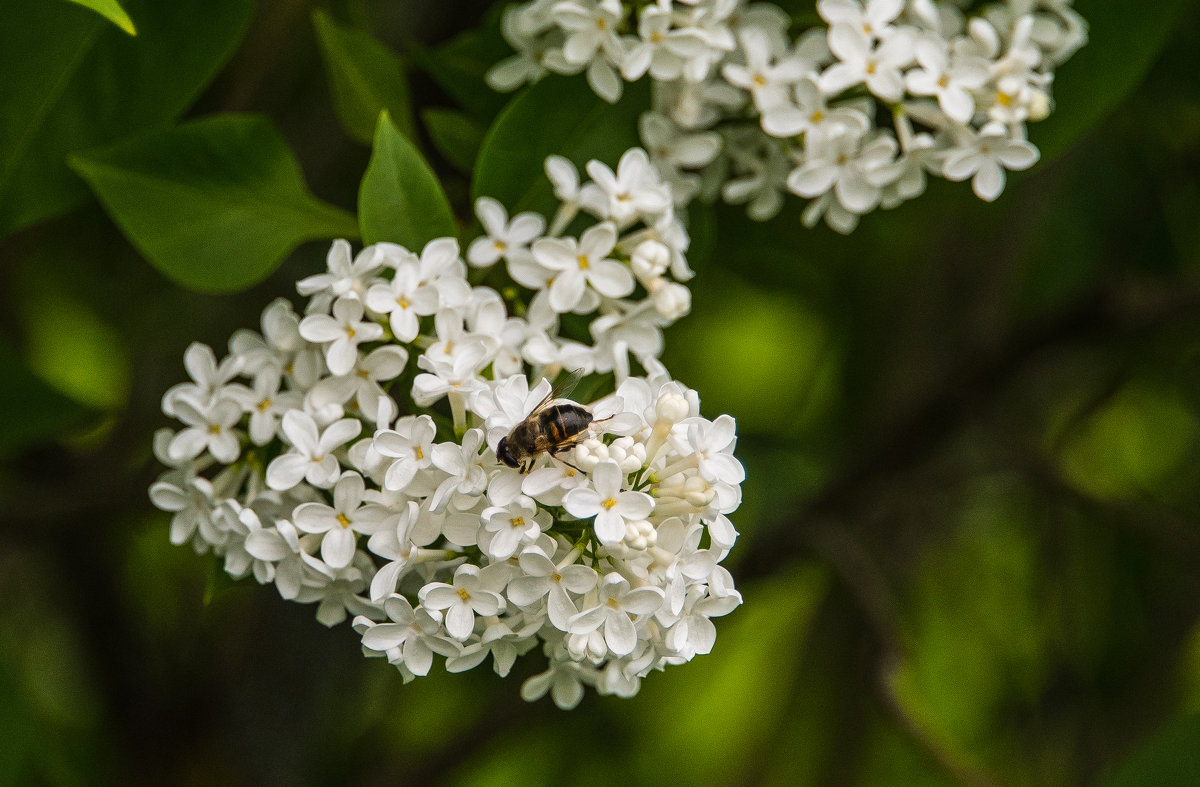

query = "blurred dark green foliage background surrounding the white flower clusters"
[0,0,1200,785]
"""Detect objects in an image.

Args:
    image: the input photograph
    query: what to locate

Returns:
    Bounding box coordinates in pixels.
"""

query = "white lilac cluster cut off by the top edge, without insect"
[488,0,1087,233]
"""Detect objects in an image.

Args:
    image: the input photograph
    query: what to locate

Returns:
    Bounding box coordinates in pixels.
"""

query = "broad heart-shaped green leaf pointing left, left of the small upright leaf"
[71,115,358,293]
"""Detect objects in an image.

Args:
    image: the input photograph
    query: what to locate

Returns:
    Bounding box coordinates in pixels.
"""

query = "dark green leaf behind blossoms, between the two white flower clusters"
[472,77,649,215]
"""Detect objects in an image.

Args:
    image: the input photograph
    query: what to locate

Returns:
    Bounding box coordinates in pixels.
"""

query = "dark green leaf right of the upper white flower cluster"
[1030,0,1186,162]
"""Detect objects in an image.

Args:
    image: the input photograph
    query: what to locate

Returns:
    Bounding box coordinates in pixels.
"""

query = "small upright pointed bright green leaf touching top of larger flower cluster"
[359,110,458,251]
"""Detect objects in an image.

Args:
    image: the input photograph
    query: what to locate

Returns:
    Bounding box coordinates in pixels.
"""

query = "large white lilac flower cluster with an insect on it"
[150,151,744,708]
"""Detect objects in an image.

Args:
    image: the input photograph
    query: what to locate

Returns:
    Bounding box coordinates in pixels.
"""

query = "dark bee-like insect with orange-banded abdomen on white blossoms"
[496,370,597,473]
